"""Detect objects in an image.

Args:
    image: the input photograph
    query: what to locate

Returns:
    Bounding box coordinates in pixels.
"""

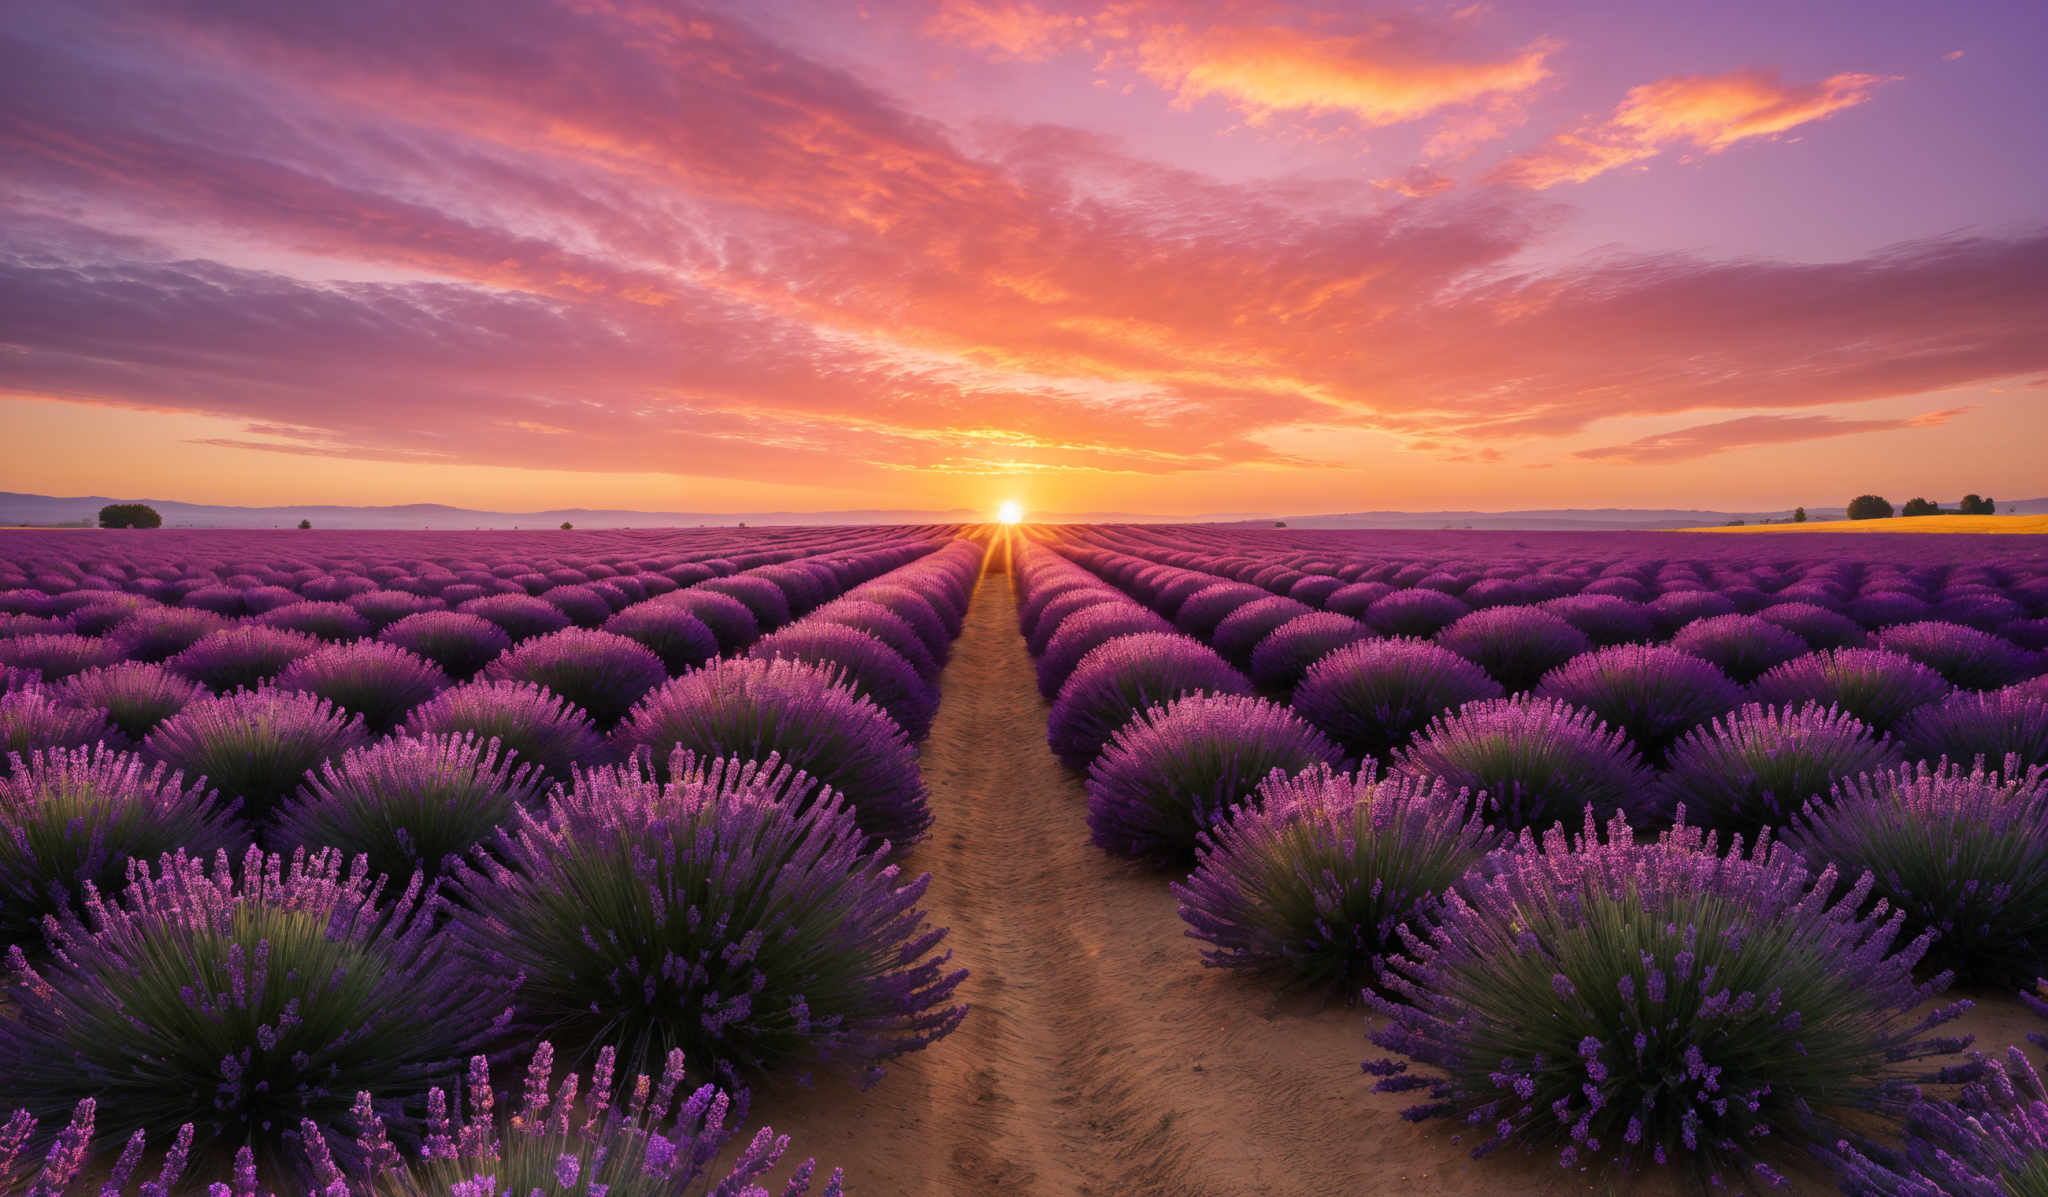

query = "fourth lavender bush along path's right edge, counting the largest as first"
[1047,631,1251,773]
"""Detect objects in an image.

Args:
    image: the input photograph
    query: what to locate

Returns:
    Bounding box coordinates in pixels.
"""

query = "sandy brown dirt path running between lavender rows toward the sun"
[756,545,2025,1197]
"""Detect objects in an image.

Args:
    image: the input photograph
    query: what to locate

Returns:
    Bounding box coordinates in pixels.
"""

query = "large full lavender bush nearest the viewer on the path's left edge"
[455,758,965,1080]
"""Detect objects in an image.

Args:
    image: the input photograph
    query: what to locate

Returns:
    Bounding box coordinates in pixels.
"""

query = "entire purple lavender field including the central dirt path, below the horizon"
[0,525,2048,1197]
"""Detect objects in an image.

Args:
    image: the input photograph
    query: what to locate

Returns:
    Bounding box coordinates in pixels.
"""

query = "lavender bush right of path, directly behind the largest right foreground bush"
[1174,767,1499,992]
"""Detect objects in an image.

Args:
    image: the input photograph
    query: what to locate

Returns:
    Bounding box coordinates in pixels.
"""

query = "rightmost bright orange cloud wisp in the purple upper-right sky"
[1495,70,1890,191]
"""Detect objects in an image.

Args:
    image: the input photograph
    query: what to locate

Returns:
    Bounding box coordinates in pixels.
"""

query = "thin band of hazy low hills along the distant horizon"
[0,492,2048,531]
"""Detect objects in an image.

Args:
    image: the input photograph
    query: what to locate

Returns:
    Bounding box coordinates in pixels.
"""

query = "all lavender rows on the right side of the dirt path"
[1016,529,2048,1195]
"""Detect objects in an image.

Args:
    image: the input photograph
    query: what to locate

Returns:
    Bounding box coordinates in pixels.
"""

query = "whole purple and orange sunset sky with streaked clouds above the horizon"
[0,0,2048,514]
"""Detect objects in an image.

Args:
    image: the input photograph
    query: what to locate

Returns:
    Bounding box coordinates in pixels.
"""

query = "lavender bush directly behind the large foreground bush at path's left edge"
[614,660,932,849]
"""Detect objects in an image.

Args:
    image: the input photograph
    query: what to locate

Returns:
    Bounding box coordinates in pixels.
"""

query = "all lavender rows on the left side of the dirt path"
[0,531,981,1193]
